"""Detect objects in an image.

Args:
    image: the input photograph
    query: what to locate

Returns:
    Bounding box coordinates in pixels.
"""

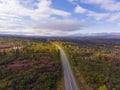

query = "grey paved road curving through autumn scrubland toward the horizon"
[56,45,78,90]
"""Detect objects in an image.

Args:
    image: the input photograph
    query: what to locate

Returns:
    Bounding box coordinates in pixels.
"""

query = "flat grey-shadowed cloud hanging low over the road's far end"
[34,19,83,31]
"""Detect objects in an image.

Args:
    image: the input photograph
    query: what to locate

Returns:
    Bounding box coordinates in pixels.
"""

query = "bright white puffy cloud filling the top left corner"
[0,0,70,20]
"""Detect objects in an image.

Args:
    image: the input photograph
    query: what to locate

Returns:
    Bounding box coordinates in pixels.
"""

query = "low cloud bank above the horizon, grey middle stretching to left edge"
[0,19,83,36]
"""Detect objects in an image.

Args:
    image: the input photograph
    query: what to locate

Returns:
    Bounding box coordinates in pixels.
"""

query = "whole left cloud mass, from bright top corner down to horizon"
[0,0,81,35]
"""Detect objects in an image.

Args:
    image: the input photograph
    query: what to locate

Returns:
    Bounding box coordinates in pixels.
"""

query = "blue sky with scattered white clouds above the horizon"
[0,0,120,36]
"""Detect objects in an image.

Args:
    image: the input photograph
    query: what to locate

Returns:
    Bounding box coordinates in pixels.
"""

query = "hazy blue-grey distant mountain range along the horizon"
[0,33,120,39]
